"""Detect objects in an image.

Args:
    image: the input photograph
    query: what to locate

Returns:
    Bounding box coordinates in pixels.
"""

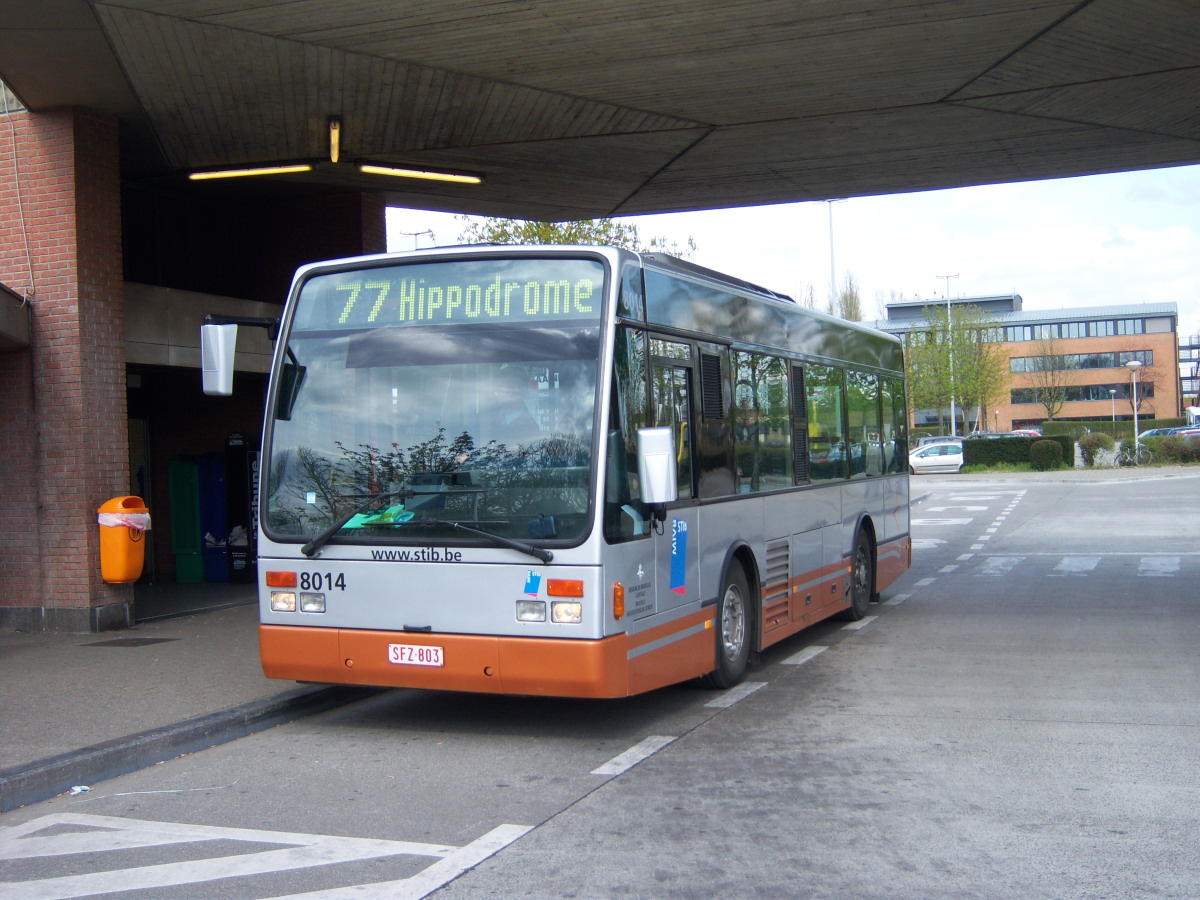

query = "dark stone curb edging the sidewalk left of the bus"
[0,686,378,812]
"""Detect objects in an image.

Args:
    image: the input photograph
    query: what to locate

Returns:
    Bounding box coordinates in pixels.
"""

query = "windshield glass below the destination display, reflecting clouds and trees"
[264,323,599,542]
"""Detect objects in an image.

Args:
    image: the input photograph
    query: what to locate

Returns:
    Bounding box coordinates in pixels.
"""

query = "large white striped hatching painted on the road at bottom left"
[0,812,532,900]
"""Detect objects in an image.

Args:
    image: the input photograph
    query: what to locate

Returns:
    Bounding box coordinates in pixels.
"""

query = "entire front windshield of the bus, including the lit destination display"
[263,257,605,544]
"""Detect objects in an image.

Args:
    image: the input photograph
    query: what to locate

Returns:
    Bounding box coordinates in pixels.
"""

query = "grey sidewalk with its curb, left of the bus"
[0,595,366,812]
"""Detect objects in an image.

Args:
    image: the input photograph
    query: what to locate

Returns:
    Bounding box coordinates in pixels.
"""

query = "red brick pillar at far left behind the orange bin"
[0,109,132,630]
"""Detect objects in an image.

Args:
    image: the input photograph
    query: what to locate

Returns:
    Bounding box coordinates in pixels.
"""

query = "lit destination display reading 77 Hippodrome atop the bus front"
[294,257,604,330]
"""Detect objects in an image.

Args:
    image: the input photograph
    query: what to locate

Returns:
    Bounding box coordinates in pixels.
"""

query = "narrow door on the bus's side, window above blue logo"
[650,355,701,612]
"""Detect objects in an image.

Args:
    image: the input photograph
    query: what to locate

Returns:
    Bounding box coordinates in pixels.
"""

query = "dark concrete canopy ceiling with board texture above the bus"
[0,0,1200,220]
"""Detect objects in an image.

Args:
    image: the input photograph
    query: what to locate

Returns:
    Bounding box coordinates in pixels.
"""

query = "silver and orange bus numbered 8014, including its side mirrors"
[202,246,912,697]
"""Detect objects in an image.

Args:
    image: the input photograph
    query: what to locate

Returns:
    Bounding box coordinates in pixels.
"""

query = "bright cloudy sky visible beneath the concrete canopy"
[388,166,1200,338]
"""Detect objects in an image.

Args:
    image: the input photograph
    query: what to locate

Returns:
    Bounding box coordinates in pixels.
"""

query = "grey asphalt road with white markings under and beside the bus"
[0,473,1200,900]
